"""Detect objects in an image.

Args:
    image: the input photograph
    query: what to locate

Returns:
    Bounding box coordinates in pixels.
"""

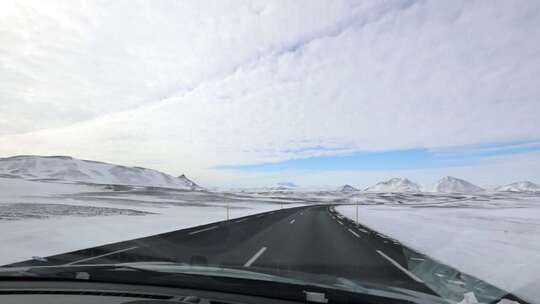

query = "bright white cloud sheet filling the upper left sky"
[0,0,362,134]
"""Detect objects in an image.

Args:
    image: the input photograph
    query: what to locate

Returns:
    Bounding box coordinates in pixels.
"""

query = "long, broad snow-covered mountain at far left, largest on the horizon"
[0,155,202,190]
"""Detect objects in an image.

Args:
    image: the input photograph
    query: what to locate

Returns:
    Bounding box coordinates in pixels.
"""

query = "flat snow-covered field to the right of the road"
[336,193,540,302]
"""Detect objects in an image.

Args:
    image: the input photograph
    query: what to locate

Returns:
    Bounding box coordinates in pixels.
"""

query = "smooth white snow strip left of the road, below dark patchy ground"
[0,204,292,265]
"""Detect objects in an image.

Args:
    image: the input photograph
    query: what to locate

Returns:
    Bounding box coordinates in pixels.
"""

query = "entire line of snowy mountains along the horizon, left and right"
[0,155,540,194]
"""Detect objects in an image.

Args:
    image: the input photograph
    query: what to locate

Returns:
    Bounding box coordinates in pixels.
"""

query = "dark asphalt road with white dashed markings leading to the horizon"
[10,206,432,293]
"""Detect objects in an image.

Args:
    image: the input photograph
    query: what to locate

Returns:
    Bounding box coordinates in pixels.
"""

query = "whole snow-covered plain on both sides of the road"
[0,171,540,302]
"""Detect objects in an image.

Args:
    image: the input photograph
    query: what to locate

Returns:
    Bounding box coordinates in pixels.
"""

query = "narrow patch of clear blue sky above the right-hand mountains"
[218,141,540,172]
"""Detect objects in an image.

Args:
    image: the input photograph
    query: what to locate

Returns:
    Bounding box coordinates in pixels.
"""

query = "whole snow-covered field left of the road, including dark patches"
[0,178,302,265]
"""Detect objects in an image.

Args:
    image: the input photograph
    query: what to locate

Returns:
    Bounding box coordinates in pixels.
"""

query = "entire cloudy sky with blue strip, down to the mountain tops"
[0,0,540,187]
